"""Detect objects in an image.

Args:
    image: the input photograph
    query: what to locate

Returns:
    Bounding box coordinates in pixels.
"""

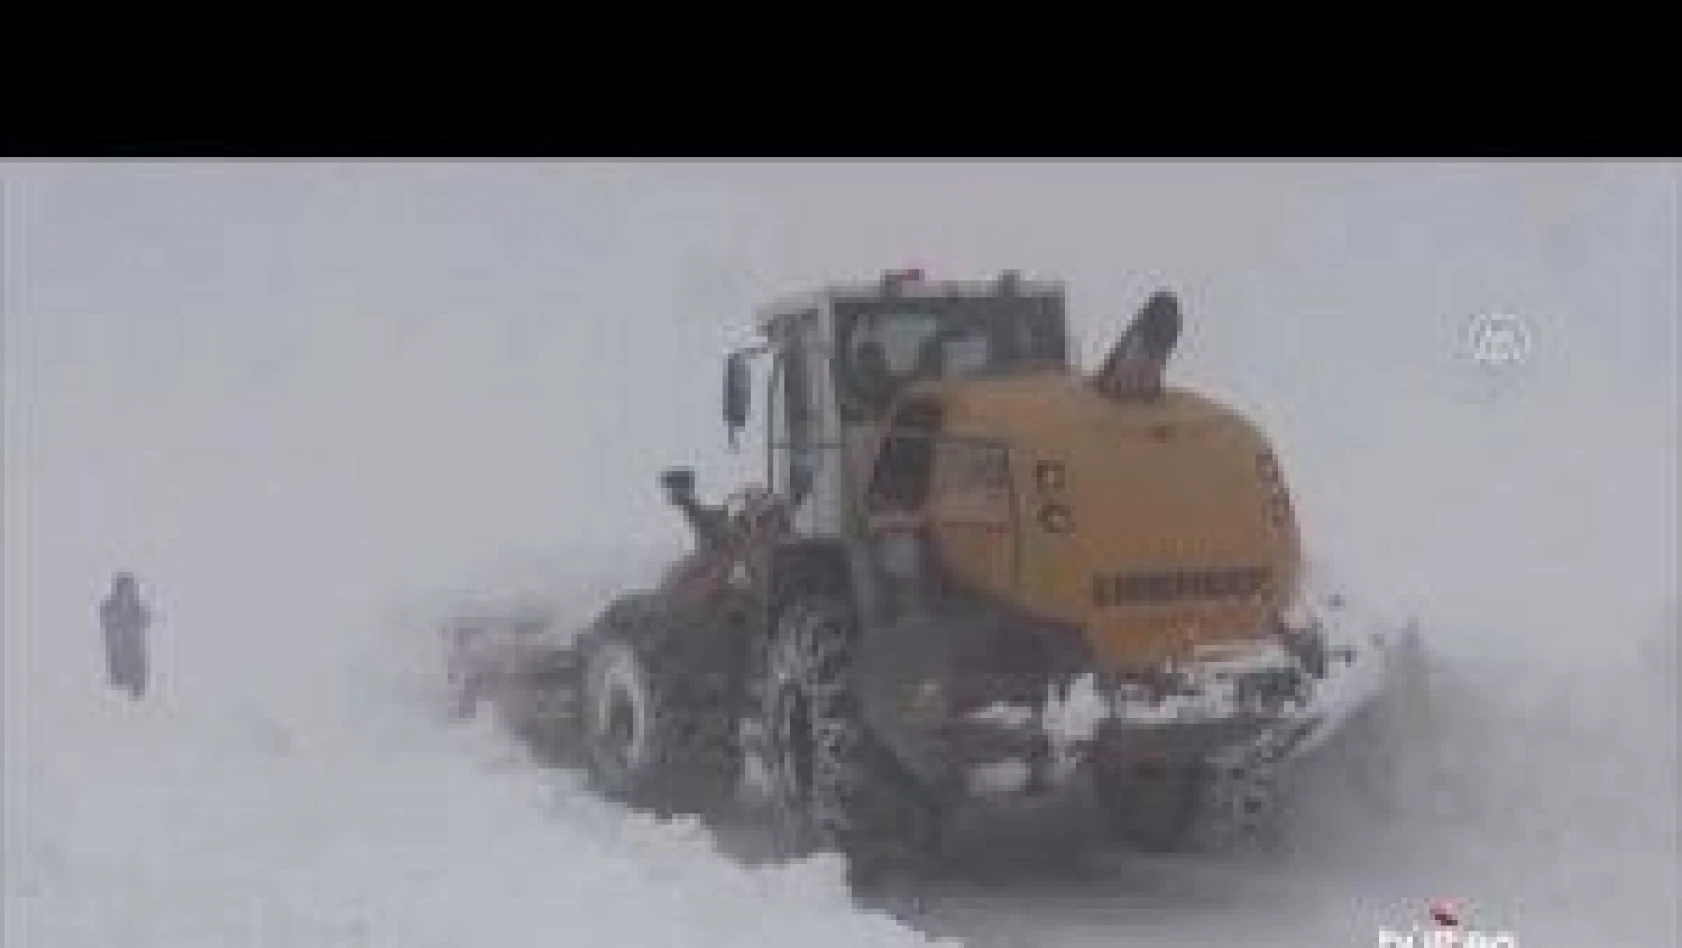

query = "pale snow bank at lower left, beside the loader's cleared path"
[5,537,925,948]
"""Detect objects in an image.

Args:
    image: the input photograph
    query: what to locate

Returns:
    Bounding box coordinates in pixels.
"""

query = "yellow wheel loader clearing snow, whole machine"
[447,271,1396,867]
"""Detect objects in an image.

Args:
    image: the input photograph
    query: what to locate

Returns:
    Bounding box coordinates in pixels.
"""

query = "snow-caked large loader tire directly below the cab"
[760,598,939,881]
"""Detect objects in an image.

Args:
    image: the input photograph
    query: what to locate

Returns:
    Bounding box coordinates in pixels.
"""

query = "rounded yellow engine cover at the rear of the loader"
[928,375,1300,671]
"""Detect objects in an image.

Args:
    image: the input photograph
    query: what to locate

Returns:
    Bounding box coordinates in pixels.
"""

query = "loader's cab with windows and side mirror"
[725,271,1071,538]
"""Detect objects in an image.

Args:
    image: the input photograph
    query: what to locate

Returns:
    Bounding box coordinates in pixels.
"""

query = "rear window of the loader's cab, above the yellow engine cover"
[836,296,1068,420]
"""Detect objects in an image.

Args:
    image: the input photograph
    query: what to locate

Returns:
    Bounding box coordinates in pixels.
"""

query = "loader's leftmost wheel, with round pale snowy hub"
[579,598,740,815]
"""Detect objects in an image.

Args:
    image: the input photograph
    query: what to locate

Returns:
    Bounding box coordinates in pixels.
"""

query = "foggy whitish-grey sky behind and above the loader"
[0,161,1679,658]
